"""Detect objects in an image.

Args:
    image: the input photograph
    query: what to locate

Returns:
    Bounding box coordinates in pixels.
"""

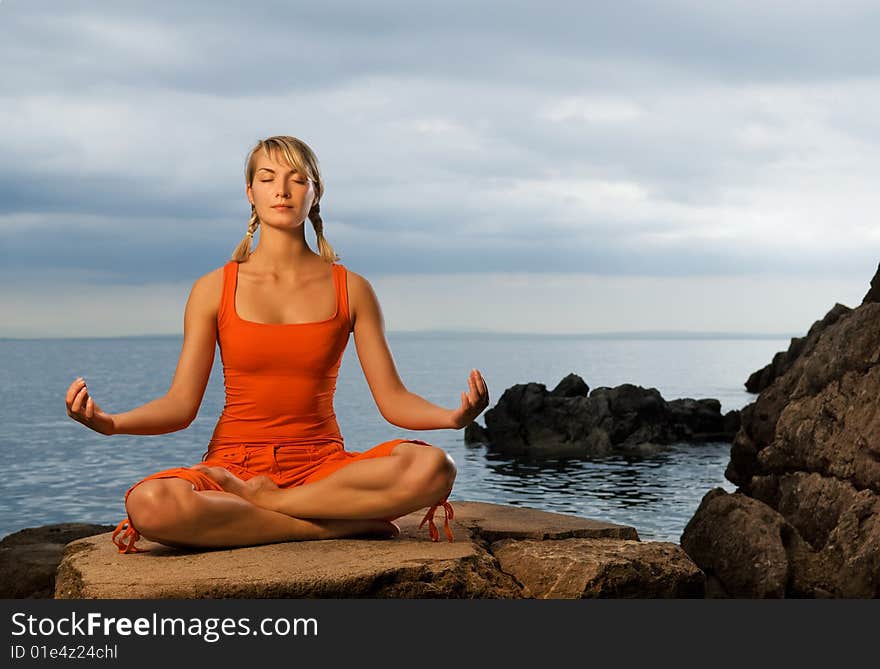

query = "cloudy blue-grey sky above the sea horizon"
[0,0,880,337]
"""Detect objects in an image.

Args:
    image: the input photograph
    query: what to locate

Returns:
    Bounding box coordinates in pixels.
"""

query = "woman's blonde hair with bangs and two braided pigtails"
[231,135,339,263]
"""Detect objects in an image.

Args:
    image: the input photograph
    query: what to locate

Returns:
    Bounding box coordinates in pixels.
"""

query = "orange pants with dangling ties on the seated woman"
[111,439,453,553]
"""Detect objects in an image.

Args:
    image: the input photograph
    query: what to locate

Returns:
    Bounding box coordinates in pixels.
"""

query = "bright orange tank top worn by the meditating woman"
[208,260,351,451]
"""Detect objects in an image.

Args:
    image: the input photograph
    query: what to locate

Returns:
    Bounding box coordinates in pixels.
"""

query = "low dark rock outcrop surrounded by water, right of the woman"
[464,374,739,457]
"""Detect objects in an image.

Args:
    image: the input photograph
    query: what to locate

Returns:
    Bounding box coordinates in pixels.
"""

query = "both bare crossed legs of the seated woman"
[126,442,456,547]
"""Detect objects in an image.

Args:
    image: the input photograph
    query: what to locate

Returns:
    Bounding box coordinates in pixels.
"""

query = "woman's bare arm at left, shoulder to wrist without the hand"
[112,267,223,434]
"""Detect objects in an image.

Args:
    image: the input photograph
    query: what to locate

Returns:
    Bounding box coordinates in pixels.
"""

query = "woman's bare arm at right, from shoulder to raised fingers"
[348,270,488,430]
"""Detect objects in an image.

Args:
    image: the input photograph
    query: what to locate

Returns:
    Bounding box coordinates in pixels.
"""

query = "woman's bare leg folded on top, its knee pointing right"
[193,441,456,519]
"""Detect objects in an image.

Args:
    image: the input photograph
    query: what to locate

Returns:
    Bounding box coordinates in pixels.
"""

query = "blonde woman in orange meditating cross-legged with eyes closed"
[66,136,488,553]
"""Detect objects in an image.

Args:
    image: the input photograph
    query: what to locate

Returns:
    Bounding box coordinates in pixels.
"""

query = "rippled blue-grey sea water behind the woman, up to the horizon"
[0,333,789,543]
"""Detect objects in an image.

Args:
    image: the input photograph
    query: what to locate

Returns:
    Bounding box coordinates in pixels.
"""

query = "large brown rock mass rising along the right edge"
[681,260,880,598]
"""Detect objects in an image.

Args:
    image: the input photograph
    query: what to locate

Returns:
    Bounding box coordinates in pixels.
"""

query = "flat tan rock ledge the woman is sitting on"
[55,501,701,599]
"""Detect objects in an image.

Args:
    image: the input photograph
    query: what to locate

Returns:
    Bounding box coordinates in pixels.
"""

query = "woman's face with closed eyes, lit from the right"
[247,152,315,227]
